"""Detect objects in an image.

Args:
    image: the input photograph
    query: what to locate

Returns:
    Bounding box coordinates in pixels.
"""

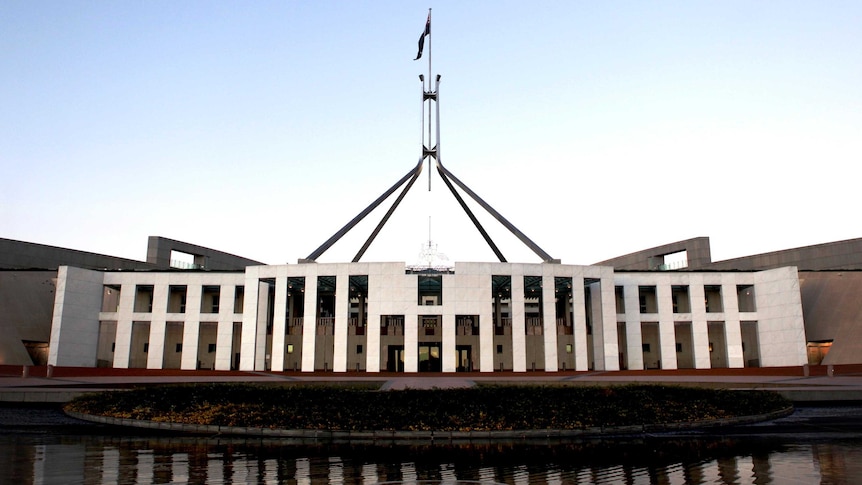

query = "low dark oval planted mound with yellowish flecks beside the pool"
[65,384,791,431]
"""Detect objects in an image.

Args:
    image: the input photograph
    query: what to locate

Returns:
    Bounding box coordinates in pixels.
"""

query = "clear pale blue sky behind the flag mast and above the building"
[0,0,862,264]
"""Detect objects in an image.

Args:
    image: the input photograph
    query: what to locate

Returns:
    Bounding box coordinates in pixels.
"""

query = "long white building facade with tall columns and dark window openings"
[49,263,807,373]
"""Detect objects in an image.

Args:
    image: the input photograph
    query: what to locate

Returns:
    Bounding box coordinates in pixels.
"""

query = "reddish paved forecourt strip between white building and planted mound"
[0,365,862,403]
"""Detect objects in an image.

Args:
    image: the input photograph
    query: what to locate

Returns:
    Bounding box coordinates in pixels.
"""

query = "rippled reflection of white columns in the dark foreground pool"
[5,436,862,485]
